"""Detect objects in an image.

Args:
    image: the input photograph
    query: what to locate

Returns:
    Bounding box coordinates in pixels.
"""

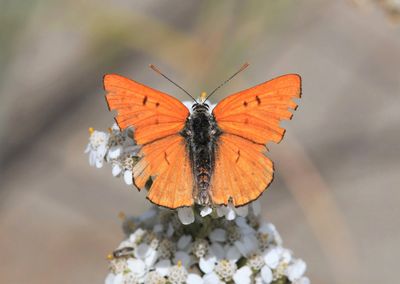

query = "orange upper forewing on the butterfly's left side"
[104,74,189,145]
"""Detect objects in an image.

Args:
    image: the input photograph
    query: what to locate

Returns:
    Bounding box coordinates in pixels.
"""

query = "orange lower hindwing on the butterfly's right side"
[210,133,274,206]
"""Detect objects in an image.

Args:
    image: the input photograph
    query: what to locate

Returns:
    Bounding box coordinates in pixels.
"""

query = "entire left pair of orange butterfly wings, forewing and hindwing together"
[104,74,193,208]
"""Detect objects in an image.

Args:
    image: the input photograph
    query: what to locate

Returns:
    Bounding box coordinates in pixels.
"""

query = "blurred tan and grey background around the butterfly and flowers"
[0,0,400,284]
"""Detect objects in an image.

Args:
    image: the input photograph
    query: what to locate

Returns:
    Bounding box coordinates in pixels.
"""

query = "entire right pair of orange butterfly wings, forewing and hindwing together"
[211,74,301,206]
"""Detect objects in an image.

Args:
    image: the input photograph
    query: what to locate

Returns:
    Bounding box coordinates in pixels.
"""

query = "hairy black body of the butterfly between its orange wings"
[181,103,221,205]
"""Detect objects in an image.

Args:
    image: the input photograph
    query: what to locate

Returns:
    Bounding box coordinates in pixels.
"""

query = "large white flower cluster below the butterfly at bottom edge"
[105,206,310,284]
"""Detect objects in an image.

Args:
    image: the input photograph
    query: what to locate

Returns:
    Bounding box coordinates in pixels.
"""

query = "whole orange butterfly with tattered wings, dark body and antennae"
[104,64,301,209]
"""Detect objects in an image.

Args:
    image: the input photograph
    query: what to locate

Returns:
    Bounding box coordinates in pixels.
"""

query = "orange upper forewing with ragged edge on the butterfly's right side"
[213,74,300,144]
